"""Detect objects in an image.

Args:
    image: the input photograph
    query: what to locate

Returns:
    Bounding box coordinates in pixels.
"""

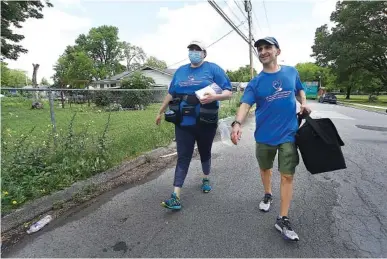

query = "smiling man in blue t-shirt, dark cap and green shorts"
[231,37,309,241]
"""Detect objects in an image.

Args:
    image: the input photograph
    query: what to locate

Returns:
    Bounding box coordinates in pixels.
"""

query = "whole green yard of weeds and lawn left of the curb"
[1,97,174,213]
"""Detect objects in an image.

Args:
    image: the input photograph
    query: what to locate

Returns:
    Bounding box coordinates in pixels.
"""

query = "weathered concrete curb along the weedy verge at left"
[1,146,176,234]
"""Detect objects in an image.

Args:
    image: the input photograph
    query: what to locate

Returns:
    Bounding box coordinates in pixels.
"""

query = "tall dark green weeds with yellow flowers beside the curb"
[1,113,112,215]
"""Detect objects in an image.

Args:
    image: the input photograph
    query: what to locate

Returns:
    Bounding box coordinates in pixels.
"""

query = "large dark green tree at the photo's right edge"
[312,1,387,99]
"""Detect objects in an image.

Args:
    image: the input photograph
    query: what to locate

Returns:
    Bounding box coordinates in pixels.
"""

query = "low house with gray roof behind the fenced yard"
[91,66,176,88]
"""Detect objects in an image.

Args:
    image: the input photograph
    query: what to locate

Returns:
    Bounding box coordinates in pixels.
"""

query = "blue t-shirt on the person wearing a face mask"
[168,61,232,126]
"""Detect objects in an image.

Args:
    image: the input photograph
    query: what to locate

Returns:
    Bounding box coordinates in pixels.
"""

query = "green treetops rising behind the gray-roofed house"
[53,25,167,86]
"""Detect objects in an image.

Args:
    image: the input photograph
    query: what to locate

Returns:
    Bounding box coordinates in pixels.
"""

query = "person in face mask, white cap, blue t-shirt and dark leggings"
[156,41,232,210]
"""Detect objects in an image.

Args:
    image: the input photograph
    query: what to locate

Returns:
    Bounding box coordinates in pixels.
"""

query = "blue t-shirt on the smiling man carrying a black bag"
[241,66,304,146]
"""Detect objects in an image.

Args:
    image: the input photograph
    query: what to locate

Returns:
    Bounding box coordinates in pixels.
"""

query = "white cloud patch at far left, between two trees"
[6,5,91,82]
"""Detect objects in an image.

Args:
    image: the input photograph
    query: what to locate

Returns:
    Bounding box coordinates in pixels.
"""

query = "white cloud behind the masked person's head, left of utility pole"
[133,2,260,72]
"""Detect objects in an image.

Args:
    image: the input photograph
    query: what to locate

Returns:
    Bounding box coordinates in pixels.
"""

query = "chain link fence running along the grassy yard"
[1,88,240,213]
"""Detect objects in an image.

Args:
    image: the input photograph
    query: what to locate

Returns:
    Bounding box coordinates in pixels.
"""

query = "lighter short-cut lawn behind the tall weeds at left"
[1,98,173,163]
